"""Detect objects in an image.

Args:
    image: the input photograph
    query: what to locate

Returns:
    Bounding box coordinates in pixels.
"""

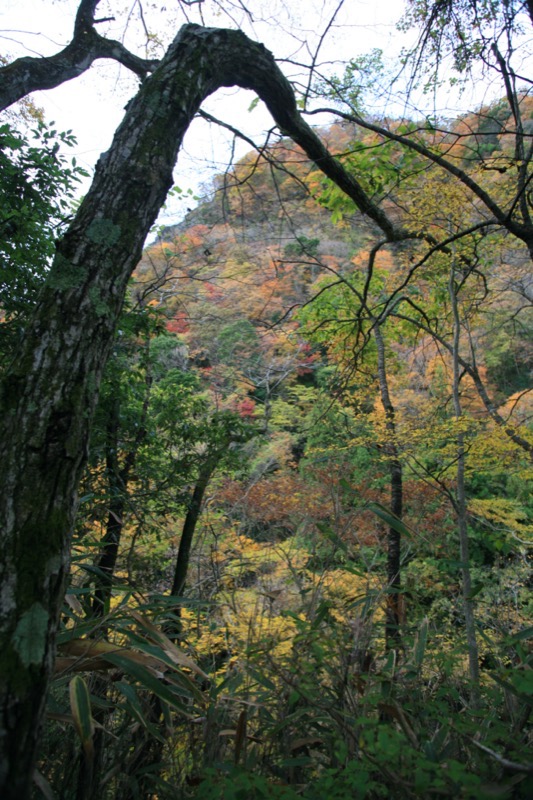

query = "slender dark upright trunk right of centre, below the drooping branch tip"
[373,322,403,650]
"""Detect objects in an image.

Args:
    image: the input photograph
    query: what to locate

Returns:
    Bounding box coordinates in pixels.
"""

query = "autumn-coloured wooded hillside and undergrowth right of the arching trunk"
[35,111,532,798]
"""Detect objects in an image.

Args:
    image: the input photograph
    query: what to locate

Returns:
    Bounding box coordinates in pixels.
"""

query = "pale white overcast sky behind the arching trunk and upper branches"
[0,0,420,223]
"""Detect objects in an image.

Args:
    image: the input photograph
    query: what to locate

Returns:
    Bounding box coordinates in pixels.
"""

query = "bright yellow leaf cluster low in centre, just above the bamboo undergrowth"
[177,520,392,683]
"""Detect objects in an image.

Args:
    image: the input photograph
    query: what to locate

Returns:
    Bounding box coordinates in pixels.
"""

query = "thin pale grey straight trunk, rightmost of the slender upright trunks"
[449,265,479,703]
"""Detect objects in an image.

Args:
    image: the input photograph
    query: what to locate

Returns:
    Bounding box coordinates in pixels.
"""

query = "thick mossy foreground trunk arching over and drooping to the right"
[0,23,406,800]
